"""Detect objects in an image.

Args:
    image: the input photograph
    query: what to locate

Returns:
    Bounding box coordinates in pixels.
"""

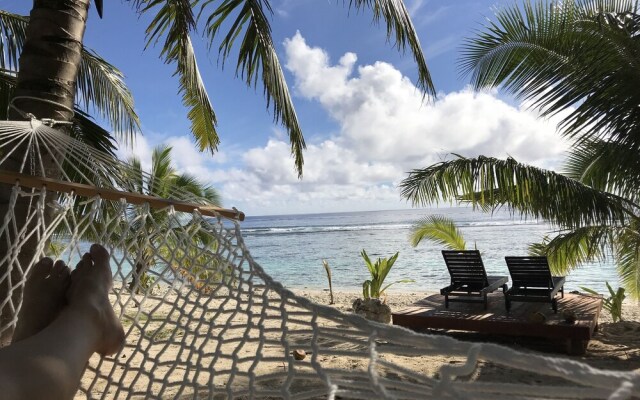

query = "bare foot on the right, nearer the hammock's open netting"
[67,244,124,355]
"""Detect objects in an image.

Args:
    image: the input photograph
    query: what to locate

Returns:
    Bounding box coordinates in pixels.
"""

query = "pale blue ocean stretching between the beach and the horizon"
[240,207,619,293]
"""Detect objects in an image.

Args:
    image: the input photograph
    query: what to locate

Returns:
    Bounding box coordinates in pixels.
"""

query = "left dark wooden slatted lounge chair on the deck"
[440,250,509,310]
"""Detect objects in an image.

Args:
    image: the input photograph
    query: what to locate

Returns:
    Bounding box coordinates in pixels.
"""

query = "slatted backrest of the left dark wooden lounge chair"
[442,250,488,287]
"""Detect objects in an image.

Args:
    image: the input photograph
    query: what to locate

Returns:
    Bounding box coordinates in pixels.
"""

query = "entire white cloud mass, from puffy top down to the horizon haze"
[119,33,567,215]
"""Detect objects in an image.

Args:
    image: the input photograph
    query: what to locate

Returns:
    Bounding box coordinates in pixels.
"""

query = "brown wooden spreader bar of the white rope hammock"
[0,170,244,221]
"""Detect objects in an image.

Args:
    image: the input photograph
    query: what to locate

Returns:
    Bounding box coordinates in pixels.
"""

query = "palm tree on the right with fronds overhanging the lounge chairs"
[401,0,640,299]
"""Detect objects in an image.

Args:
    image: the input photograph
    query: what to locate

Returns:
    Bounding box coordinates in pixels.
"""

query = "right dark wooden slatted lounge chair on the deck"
[504,257,565,313]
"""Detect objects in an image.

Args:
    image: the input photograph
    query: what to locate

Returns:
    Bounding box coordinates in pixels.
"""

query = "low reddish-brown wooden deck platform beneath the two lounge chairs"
[392,292,602,354]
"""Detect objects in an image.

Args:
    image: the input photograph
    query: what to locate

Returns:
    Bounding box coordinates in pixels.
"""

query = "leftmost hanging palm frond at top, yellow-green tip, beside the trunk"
[132,0,220,153]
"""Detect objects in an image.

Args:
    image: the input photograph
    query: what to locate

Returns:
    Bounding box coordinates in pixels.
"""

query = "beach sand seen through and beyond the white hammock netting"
[78,288,640,398]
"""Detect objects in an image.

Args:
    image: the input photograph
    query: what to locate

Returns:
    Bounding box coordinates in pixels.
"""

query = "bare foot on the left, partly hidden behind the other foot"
[12,257,70,343]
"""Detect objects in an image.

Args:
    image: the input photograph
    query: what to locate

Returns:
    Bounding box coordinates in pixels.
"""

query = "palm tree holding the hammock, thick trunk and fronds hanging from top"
[0,0,435,340]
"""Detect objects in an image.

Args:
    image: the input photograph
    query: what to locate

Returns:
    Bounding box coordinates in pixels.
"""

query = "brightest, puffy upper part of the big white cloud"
[285,33,566,168]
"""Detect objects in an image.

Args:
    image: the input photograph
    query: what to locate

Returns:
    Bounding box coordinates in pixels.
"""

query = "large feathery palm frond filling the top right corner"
[460,0,640,149]
